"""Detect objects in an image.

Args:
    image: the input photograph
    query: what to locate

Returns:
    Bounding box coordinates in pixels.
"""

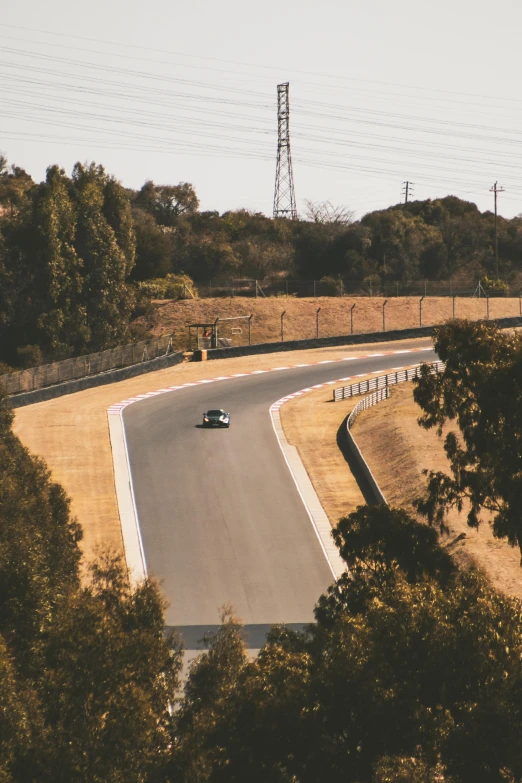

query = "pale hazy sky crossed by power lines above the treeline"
[0,0,522,217]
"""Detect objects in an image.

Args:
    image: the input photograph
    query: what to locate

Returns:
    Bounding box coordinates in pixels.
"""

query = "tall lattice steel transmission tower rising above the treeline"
[274,82,297,220]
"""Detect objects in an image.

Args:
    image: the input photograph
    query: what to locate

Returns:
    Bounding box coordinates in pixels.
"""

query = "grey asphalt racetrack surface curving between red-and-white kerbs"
[124,343,436,649]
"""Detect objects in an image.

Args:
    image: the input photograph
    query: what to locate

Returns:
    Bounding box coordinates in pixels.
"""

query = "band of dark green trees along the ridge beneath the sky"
[0,156,522,371]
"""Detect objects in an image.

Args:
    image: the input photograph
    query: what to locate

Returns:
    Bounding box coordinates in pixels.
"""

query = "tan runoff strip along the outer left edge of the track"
[15,338,431,558]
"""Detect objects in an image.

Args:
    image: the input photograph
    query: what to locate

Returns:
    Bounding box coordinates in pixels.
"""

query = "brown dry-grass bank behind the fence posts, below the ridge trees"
[138,297,520,348]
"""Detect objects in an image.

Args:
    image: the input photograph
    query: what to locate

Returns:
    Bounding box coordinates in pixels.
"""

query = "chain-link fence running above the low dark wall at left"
[0,334,174,395]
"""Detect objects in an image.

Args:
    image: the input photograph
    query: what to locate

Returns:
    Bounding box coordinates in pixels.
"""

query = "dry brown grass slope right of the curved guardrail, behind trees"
[354,383,522,598]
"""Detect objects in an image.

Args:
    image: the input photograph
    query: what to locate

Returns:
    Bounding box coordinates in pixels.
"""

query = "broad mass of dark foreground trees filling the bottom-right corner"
[172,507,522,783]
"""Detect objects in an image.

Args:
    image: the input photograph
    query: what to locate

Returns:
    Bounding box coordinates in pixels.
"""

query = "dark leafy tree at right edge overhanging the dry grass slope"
[414,320,522,551]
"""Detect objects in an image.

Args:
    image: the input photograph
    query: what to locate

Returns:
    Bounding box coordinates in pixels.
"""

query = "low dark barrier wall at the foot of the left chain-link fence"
[5,352,183,408]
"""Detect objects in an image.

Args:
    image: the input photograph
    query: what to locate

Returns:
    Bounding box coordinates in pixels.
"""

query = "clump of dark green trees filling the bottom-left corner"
[0,406,182,783]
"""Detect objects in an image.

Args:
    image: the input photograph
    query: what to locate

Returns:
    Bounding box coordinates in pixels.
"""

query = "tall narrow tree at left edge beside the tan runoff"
[0,407,82,675]
